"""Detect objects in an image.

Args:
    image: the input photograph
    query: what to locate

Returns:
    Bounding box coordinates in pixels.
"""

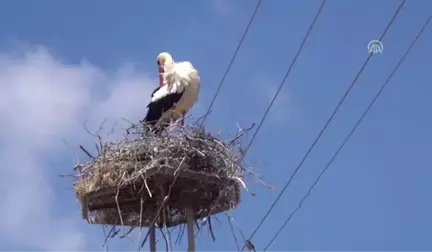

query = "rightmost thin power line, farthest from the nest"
[264,11,432,252]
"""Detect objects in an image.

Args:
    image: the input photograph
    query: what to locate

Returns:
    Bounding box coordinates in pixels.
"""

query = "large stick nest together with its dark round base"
[74,122,244,227]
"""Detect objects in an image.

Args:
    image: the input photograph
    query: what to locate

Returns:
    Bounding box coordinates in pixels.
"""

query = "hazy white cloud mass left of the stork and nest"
[0,47,157,252]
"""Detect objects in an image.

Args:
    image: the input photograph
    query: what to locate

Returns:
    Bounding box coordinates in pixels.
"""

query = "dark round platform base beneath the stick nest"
[78,167,241,227]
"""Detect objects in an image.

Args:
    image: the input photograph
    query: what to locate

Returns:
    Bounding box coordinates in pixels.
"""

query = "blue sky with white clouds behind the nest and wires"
[0,0,432,252]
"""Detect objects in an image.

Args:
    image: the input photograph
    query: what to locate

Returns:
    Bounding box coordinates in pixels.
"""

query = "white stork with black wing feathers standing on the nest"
[144,52,201,132]
